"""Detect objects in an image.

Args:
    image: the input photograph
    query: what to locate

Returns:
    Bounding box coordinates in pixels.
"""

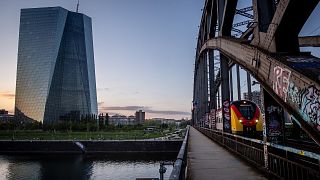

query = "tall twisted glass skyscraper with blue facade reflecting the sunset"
[15,7,98,124]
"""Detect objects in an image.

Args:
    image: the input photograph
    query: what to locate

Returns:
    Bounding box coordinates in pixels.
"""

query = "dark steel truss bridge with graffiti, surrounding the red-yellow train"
[185,0,320,179]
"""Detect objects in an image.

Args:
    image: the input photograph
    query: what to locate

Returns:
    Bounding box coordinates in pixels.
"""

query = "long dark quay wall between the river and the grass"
[0,140,182,154]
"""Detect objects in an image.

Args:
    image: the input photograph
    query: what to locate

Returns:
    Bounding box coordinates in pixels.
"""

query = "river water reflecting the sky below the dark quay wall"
[0,155,173,180]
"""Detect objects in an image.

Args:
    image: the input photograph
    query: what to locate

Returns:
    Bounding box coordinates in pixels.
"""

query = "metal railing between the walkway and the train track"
[196,127,320,180]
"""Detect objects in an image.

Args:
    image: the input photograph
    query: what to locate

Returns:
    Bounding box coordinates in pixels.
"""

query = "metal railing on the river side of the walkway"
[169,126,190,180]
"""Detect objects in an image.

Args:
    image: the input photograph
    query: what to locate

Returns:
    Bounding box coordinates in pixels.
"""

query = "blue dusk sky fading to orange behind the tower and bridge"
[0,0,320,119]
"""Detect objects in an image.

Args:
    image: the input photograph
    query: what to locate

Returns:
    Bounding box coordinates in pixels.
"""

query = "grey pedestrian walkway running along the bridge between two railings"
[187,127,267,180]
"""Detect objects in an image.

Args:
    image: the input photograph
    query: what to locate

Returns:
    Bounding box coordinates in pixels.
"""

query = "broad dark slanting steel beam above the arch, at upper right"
[258,0,319,53]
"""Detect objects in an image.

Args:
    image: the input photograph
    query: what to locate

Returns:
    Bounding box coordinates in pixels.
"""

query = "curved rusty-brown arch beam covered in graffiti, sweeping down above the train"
[199,37,320,145]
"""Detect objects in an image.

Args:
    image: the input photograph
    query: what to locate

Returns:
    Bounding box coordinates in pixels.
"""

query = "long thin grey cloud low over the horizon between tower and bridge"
[99,106,191,116]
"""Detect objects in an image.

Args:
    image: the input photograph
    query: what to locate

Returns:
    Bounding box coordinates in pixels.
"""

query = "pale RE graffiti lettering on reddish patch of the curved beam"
[272,66,291,102]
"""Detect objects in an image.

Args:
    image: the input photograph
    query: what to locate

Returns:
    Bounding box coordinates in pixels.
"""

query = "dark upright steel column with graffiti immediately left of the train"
[220,53,231,133]
